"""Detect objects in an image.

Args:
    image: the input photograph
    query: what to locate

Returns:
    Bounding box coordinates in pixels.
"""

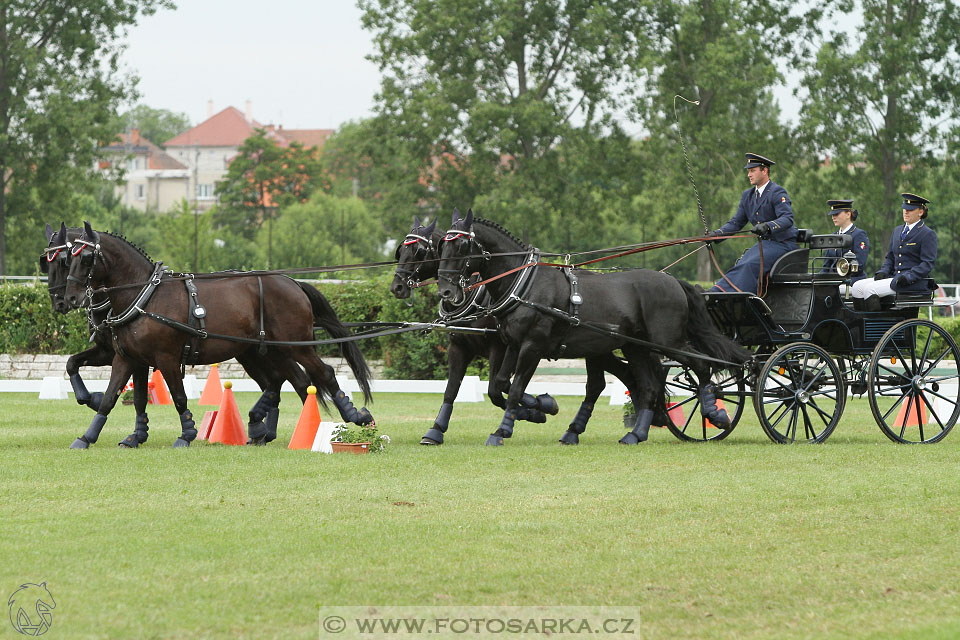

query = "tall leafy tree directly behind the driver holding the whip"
[635,0,803,280]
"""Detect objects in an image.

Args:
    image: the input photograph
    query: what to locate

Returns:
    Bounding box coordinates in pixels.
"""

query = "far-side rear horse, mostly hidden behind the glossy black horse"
[390,215,634,445]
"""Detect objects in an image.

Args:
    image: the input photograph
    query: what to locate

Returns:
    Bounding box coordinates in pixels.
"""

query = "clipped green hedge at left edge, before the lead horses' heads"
[0,283,90,354]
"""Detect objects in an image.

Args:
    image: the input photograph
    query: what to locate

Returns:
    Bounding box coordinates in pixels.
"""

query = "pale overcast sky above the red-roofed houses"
[125,0,856,134]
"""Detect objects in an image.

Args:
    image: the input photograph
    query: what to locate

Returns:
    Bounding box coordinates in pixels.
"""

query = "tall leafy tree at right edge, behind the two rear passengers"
[800,0,960,272]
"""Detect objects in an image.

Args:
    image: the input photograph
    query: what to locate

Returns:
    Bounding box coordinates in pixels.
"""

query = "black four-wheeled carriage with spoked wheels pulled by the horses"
[666,229,960,443]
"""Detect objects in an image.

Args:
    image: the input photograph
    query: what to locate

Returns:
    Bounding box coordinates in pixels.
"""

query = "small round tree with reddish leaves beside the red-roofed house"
[217,129,323,268]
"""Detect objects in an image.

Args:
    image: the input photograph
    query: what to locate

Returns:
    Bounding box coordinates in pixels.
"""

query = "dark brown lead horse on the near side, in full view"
[65,223,373,448]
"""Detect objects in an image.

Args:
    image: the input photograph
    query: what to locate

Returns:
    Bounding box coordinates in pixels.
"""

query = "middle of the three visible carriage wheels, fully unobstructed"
[754,342,846,444]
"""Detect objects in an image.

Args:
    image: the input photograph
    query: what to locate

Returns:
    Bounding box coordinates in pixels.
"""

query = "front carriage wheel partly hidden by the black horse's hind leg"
[666,366,746,442]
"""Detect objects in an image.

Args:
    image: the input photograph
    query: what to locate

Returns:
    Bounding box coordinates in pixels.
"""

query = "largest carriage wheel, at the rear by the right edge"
[869,319,960,444]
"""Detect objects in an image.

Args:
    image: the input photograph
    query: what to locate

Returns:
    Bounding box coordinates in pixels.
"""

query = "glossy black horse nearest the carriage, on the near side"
[438,211,751,444]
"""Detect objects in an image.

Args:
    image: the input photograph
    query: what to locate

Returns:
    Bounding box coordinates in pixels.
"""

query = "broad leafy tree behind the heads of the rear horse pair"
[360,0,641,244]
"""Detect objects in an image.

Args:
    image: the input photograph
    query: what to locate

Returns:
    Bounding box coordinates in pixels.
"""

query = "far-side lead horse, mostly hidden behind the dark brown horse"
[40,223,318,449]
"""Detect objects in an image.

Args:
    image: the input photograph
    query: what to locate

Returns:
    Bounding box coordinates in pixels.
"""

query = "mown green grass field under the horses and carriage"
[0,393,960,639]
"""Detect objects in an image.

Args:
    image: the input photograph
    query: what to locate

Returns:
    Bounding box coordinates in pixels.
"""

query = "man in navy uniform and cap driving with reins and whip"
[707,153,797,293]
